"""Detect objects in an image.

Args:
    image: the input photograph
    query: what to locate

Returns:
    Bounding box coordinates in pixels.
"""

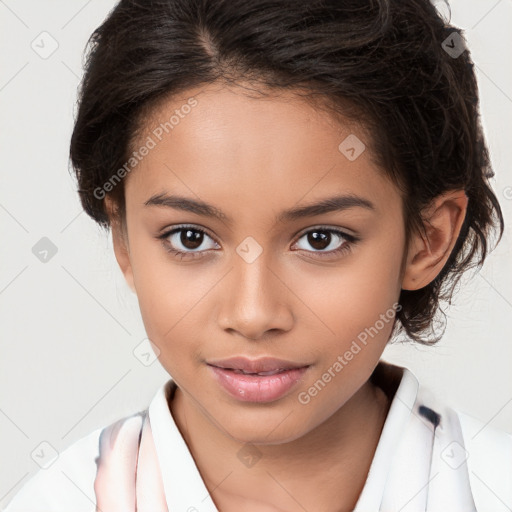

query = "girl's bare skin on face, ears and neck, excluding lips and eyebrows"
[106,84,467,512]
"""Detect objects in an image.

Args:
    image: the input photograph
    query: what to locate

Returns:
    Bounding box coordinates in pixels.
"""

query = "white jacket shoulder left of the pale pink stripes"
[4,412,148,512]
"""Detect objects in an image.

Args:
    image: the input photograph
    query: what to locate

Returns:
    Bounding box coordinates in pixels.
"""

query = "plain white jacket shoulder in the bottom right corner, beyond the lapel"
[456,411,512,512]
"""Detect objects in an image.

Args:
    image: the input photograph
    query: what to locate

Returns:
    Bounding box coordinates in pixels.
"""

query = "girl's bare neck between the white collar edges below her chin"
[169,380,390,512]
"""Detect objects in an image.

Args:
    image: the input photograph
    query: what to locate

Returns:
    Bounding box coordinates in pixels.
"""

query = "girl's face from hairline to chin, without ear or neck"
[116,85,405,443]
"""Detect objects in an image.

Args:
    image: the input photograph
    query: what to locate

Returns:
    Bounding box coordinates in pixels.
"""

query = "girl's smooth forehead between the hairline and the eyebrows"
[126,84,398,219]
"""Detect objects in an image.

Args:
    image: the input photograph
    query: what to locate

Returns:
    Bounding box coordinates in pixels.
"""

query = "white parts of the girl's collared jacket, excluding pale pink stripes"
[5,361,512,512]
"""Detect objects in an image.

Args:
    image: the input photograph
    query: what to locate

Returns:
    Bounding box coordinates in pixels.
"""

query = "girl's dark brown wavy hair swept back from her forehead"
[70,0,504,345]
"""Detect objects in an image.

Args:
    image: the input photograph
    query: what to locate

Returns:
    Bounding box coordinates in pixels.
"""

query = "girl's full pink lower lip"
[208,365,309,402]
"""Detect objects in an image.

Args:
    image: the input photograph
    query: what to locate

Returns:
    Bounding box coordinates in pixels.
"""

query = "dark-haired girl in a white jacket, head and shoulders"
[7,0,512,512]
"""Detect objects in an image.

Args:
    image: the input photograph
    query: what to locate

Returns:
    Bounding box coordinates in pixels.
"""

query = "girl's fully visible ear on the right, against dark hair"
[402,190,468,290]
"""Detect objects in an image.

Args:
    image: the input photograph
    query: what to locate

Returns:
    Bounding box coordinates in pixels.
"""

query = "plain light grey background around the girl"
[0,0,512,505]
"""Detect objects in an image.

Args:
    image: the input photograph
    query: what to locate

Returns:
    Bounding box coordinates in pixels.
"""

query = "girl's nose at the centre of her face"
[218,247,294,341]
